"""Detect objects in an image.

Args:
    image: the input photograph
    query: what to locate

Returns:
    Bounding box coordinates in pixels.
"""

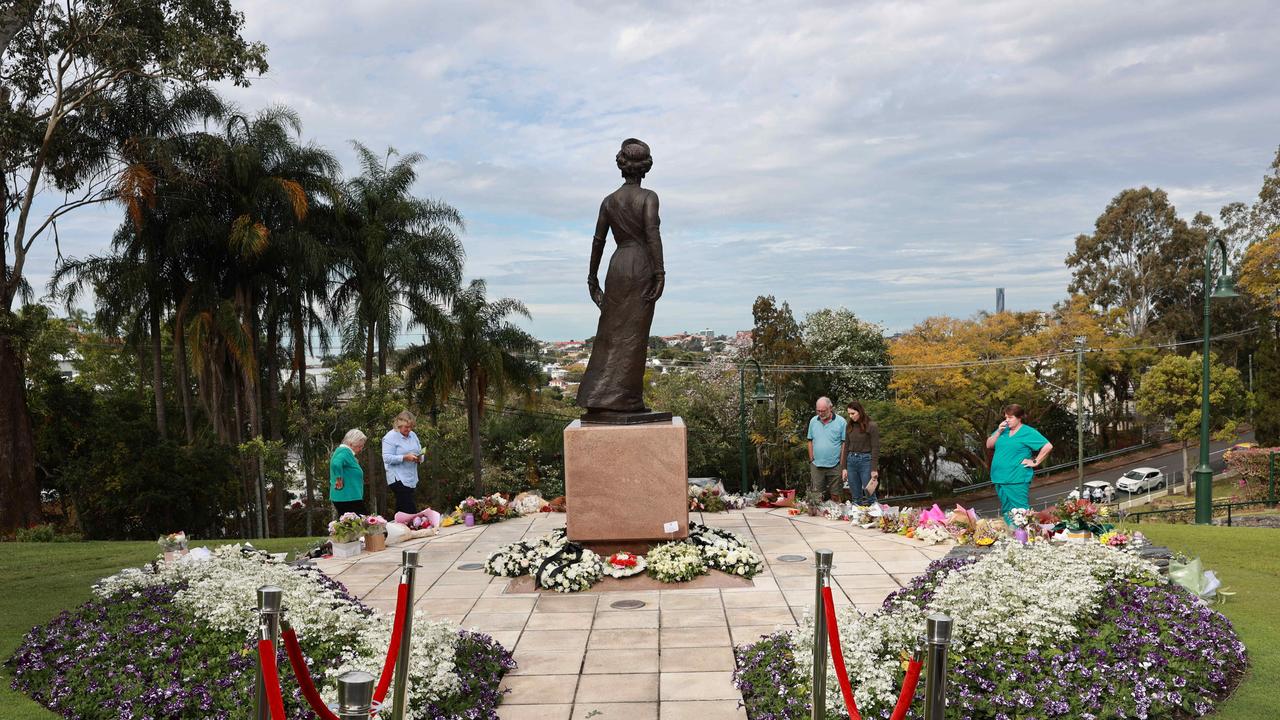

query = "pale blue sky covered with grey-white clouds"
[24,0,1280,338]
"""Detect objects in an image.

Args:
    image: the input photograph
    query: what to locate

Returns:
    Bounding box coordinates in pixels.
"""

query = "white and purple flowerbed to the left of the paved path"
[6,546,515,720]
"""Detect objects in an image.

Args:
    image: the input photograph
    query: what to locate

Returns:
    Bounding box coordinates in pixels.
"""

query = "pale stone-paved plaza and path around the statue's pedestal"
[319,509,948,720]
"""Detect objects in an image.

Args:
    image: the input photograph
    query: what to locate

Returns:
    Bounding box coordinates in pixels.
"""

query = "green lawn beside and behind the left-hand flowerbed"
[0,538,319,720]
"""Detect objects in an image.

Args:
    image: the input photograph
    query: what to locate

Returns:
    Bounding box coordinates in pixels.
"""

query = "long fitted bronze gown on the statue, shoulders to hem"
[577,183,663,413]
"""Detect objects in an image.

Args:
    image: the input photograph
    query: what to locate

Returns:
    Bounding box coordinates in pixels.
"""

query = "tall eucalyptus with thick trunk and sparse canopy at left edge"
[0,0,266,532]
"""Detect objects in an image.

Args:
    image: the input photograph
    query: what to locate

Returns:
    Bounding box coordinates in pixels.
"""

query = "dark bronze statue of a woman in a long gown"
[577,137,671,424]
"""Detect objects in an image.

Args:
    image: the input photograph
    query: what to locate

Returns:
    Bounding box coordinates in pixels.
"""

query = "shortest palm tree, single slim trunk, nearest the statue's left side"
[399,279,539,497]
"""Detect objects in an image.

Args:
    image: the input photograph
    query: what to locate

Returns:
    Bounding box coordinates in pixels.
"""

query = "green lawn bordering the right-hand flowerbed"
[1138,523,1280,720]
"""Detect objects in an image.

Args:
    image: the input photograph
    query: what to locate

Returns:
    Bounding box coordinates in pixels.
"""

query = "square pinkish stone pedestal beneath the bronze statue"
[564,418,689,544]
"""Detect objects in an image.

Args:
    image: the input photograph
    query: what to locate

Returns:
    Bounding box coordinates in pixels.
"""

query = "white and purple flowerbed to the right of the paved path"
[735,543,1245,720]
